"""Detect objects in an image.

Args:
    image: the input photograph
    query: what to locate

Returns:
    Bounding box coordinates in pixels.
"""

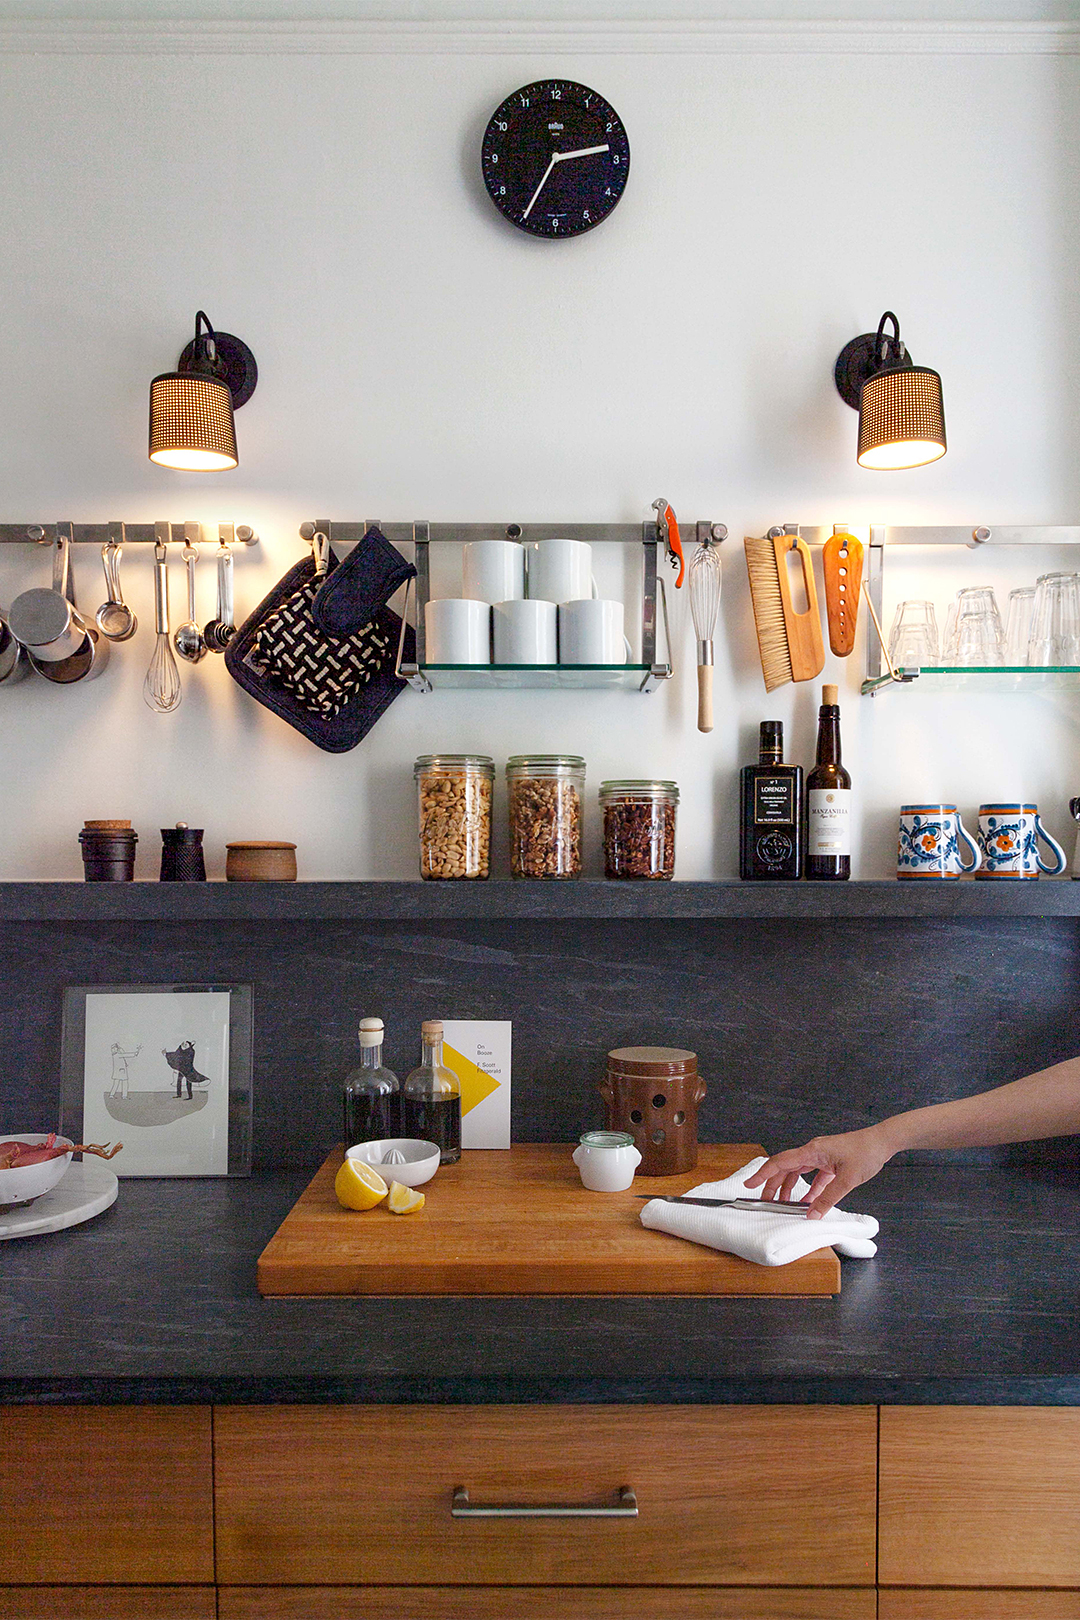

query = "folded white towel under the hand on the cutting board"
[641,1158,878,1265]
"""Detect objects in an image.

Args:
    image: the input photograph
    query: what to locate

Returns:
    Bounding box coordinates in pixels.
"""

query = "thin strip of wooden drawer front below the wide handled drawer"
[220,1586,880,1620]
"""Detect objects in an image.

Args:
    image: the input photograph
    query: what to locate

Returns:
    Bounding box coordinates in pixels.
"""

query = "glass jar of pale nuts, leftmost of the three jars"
[413,753,495,878]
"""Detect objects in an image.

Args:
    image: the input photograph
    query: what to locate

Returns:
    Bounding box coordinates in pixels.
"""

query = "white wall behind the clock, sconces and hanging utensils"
[0,19,1080,878]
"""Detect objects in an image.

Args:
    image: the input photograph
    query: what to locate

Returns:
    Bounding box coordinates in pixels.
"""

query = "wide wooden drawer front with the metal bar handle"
[214,1406,876,1586]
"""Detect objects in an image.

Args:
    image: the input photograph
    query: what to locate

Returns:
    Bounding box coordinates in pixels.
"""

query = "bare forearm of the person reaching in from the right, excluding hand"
[873,1058,1080,1158]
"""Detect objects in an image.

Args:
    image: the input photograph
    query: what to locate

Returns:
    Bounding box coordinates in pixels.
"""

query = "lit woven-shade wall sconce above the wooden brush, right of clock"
[834,309,946,468]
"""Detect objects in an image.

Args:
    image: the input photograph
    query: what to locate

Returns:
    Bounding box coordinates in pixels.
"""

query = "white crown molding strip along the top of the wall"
[0,18,1080,57]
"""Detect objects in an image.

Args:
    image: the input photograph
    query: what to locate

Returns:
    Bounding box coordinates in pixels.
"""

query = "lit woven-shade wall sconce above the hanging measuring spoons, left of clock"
[151,309,259,473]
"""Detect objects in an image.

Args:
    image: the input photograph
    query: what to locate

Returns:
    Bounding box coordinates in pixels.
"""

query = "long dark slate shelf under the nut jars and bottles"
[0,878,1080,923]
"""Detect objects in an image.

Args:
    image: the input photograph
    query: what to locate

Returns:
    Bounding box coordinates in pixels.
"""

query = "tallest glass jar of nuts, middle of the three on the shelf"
[507,753,585,878]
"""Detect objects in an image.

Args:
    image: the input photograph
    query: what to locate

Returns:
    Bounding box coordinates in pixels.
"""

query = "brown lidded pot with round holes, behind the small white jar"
[601,1047,704,1176]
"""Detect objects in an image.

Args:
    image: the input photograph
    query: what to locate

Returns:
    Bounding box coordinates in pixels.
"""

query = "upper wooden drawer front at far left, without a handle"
[0,1406,214,1581]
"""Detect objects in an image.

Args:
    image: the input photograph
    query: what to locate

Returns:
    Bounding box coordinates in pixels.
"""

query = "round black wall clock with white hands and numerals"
[481,79,630,238]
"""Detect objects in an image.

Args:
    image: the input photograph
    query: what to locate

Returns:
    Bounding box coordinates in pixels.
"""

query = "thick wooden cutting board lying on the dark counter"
[257,1142,840,1296]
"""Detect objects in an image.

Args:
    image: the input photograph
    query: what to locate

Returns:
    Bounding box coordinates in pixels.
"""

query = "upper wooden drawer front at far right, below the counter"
[878,1406,1080,1586]
